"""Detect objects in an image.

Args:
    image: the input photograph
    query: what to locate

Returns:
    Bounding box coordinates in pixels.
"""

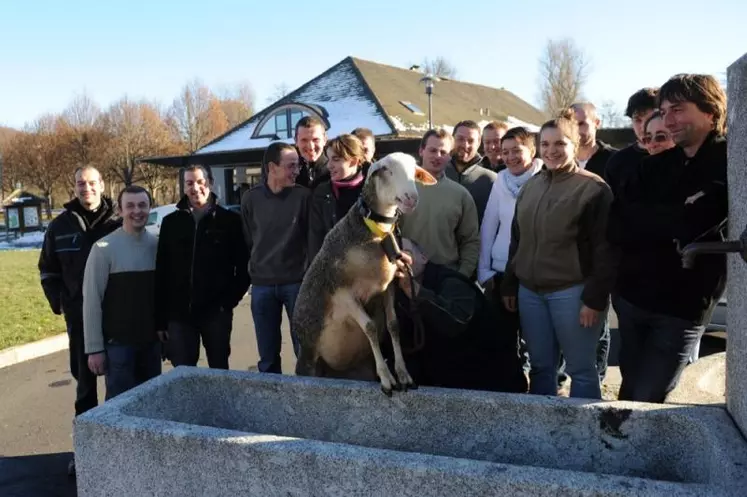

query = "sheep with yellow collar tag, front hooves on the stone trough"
[293,152,436,395]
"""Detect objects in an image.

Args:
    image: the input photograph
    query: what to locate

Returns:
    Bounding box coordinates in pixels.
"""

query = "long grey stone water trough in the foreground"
[75,367,747,497]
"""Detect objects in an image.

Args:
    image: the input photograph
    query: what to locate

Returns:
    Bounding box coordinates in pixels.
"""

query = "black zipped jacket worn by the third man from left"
[156,193,249,330]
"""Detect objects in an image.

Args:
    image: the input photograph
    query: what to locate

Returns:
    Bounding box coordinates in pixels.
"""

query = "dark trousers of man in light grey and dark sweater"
[106,342,161,400]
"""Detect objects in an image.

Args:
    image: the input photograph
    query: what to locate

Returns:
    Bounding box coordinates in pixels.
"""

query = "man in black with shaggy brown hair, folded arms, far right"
[609,74,728,402]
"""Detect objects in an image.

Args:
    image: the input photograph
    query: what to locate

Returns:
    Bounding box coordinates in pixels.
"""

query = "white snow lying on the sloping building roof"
[195,62,394,155]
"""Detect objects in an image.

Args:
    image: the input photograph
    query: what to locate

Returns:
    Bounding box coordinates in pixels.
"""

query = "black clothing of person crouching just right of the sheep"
[396,262,527,392]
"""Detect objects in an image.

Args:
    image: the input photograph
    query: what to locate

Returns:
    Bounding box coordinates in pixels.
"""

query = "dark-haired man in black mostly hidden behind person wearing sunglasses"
[604,88,659,195]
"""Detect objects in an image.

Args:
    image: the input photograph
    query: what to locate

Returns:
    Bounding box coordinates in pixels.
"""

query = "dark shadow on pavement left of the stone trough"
[0,452,77,497]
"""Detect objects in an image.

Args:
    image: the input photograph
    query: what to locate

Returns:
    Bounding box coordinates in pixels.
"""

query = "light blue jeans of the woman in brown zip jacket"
[518,285,602,399]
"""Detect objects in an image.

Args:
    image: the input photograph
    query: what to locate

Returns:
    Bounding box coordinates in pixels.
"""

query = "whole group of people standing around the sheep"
[39,74,727,472]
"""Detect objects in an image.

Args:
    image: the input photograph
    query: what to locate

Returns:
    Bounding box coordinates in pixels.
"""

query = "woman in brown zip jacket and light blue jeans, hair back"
[501,112,616,399]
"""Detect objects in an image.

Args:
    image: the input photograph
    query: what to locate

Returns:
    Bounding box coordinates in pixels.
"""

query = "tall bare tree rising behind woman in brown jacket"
[539,38,590,115]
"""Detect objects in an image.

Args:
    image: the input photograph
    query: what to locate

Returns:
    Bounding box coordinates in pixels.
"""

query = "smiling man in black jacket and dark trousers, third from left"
[156,166,249,369]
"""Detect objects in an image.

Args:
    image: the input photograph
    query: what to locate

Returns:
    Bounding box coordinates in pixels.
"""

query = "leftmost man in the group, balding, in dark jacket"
[39,167,121,473]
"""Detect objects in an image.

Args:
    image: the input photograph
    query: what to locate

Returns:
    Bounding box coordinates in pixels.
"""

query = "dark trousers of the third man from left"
[166,310,233,369]
